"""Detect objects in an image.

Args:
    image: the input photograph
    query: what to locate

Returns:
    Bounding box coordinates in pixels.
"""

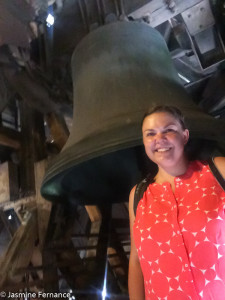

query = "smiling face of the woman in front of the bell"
[142,112,189,168]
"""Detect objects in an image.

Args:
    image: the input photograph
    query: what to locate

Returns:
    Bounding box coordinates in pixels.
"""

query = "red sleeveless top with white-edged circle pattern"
[133,161,225,300]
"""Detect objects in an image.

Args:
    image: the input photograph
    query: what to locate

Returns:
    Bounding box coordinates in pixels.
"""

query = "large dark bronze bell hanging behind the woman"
[42,22,225,204]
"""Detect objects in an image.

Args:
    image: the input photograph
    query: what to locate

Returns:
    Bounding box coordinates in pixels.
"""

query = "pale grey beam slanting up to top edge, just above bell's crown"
[129,0,203,27]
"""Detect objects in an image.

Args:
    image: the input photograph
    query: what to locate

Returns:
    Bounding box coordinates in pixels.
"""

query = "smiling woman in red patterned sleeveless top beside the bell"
[129,106,225,300]
